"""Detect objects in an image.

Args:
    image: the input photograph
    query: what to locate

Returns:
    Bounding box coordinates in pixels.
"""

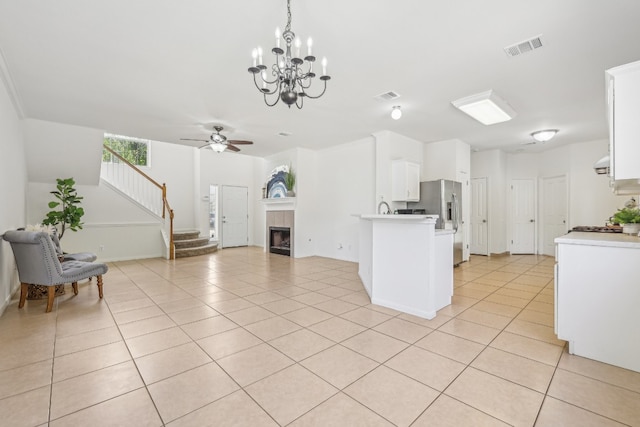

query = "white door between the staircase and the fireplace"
[221,185,249,248]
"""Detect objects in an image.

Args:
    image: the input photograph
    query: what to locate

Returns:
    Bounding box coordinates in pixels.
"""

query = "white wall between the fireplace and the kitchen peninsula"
[313,137,376,262]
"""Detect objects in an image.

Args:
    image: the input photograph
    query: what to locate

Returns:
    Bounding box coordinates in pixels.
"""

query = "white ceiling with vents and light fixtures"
[0,0,640,156]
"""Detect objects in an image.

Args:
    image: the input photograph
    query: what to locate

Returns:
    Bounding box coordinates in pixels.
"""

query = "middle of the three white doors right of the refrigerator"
[510,179,536,254]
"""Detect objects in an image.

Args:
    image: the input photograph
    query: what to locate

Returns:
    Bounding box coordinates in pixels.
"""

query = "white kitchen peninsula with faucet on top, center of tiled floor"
[358,215,453,319]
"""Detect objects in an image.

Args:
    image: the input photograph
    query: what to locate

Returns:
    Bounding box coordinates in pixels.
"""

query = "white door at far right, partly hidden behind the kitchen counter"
[542,175,568,256]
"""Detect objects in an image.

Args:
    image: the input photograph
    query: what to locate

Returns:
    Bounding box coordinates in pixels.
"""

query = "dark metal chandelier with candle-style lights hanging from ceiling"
[249,0,331,109]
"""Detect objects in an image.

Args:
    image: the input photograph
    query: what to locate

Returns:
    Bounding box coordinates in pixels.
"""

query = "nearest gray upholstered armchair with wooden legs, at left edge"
[4,231,108,313]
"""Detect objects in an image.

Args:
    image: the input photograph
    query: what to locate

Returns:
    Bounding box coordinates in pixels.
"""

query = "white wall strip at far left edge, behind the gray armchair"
[0,71,27,314]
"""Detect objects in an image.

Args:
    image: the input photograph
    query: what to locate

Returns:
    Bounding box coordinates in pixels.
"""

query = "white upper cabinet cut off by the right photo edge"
[606,61,640,181]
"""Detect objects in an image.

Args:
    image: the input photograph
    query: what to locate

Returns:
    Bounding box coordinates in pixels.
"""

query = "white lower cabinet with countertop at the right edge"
[555,233,640,372]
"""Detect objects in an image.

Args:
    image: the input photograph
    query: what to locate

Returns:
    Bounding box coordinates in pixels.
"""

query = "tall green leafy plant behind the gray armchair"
[42,178,84,239]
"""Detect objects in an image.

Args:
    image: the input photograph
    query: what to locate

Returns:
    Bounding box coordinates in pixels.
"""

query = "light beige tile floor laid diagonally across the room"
[0,248,640,427]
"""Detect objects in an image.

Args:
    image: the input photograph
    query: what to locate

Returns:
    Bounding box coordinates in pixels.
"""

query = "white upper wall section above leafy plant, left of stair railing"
[24,119,104,185]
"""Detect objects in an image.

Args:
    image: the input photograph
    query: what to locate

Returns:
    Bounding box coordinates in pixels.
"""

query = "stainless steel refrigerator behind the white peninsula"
[407,179,463,265]
